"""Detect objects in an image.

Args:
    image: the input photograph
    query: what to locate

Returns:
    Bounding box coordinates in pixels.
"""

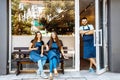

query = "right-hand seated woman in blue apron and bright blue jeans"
[47,32,67,79]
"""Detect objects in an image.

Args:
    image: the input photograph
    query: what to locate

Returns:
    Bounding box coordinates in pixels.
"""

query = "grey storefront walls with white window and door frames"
[0,0,120,75]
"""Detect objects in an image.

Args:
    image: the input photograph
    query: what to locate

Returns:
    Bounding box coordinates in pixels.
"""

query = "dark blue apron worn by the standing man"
[83,26,96,59]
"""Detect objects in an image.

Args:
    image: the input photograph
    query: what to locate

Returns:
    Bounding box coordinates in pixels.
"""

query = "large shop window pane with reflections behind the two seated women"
[11,0,75,70]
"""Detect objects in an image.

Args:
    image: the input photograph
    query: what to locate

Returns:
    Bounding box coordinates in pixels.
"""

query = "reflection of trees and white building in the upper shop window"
[12,0,75,35]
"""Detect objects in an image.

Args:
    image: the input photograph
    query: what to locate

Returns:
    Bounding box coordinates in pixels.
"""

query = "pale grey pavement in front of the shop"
[0,70,120,80]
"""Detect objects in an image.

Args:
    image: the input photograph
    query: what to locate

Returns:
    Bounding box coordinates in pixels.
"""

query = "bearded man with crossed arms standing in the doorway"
[80,17,96,72]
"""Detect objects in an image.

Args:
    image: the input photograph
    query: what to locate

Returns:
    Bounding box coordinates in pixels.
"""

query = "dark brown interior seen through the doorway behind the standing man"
[80,0,95,70]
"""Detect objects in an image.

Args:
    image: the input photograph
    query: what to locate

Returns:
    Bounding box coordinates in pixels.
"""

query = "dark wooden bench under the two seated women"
[12,47,68,75]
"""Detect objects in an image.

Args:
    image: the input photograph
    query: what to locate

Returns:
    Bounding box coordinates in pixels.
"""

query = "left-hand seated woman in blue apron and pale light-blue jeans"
[29,31,47,78]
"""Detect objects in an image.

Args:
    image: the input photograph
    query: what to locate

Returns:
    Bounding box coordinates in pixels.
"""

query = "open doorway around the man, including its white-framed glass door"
[80,0,108,74]
